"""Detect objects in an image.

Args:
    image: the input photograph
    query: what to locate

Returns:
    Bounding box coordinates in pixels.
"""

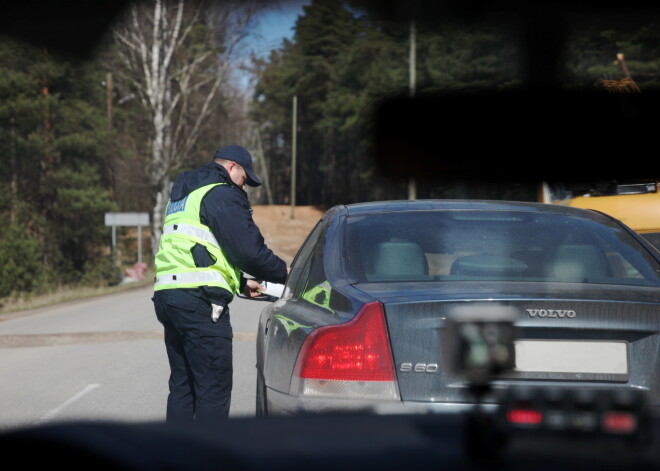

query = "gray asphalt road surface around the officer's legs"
[0,287,265,430]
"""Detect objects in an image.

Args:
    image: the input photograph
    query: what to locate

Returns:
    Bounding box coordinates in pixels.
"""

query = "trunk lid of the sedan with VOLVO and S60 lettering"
[366,291,660,403]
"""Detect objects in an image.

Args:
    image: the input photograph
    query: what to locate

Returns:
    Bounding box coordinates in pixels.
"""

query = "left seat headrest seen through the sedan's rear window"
[373,242,428,280]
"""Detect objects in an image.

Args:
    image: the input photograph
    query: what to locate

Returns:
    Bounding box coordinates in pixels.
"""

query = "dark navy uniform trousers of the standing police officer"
[153,289,232,422]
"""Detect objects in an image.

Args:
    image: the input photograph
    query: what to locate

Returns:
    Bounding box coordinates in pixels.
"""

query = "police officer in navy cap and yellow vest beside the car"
[153,145,288,422]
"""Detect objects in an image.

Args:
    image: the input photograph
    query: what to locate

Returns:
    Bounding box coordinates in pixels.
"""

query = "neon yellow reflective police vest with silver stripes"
[154,183,241,294]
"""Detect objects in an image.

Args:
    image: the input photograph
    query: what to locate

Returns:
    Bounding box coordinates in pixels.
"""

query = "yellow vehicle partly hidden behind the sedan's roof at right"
[541,181,660,250]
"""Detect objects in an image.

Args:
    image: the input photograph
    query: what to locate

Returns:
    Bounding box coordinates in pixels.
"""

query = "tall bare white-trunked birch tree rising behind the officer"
[113,0,264,254]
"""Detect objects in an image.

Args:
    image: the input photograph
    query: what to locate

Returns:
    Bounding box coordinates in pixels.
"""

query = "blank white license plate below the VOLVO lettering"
[512,340,628,381]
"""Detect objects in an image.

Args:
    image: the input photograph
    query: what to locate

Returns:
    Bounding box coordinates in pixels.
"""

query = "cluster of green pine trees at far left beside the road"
[0,39,118,294]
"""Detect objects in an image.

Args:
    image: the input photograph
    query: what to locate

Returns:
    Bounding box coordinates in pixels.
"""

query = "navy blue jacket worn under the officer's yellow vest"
[170,161,287,296]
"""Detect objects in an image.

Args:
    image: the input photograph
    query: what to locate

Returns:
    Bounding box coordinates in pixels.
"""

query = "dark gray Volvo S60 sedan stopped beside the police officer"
[257,201,660,415]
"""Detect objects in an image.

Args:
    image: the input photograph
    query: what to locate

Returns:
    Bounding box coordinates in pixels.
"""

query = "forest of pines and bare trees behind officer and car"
[0,0,660,298]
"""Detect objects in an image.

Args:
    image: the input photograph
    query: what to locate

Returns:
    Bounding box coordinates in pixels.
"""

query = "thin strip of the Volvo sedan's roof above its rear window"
[336,200,602,219]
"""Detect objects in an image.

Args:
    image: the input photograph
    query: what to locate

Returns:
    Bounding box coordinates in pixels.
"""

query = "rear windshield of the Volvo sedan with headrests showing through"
[345,210,660,286]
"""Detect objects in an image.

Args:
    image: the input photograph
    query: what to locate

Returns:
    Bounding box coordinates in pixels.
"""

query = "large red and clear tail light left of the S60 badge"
[291,302,399,399]
